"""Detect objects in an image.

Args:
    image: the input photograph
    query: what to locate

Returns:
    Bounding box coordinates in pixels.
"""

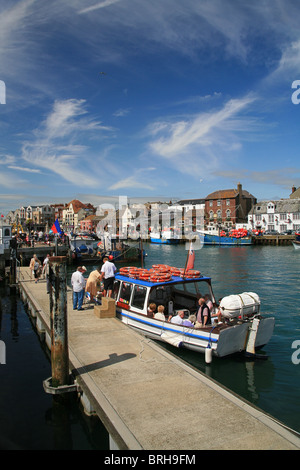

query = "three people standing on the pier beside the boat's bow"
[71,257,117,310]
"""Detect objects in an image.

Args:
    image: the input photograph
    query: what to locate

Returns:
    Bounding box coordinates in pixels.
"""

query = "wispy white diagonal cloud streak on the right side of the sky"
[148,96,255,175]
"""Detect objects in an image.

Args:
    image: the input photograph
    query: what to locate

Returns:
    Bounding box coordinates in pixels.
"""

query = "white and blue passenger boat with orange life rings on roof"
[114,265,275,362]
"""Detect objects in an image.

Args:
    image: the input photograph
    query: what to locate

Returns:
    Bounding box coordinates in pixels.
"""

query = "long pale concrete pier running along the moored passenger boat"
[19,268,300,451]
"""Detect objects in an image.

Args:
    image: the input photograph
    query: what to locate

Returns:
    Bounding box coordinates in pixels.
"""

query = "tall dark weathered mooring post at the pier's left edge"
[49,256,69,387]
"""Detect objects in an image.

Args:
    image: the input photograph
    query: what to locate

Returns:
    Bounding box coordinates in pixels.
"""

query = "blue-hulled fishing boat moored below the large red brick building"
[197,226,253,246]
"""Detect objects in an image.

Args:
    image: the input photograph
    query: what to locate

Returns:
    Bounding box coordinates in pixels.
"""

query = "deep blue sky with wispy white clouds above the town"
[0,0,300,213]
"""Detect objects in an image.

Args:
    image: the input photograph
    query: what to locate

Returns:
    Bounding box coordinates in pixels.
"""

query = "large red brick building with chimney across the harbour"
[205,183,257,226]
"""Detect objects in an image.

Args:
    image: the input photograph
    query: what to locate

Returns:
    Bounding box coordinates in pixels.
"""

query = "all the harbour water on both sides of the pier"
[0,243,300,450]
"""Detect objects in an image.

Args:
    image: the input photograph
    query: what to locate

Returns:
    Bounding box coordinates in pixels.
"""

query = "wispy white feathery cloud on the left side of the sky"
[22,99,112,186]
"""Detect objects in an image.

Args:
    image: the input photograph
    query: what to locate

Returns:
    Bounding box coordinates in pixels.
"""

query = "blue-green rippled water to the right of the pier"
[141,245,300,432]
